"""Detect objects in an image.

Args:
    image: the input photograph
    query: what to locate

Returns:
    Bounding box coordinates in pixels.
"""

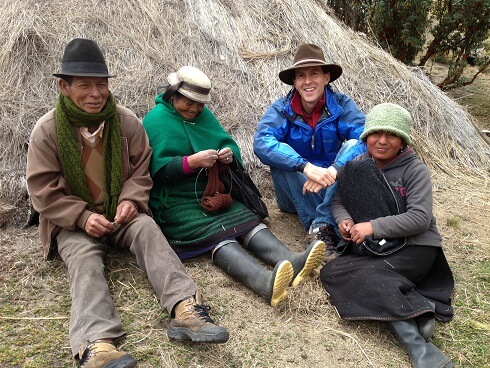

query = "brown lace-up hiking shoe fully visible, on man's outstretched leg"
[167,292,229,343]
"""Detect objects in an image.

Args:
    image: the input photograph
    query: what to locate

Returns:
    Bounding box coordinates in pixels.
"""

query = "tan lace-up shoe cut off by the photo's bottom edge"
[79,340,138,368]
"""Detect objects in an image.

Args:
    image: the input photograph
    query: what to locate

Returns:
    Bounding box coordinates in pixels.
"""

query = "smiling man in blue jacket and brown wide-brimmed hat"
[254,44,366,261]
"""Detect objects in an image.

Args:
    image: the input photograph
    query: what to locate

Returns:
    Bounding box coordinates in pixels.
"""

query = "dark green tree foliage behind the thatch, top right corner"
[326,0,490,89]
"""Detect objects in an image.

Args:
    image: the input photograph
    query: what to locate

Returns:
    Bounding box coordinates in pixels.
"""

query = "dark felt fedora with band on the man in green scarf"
[53,38,114,78]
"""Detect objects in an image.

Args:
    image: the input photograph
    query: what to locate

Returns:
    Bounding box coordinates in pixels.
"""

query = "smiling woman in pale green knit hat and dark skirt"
[320,103,454,368]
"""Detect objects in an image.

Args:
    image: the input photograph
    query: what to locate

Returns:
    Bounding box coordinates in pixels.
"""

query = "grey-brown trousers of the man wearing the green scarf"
[56,214,197,357]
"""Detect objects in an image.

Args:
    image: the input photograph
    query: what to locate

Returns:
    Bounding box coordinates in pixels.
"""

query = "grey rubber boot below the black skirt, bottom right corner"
[388,319,454,368]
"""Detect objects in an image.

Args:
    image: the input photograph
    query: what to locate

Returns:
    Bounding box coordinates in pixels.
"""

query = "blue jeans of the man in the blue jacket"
[271,139,357,230]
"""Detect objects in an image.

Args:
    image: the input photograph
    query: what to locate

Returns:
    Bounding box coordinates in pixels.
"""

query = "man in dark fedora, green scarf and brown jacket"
[27,38,228,368]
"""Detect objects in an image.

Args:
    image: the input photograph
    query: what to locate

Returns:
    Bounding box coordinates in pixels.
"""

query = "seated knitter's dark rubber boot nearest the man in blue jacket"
[245,228,326,287]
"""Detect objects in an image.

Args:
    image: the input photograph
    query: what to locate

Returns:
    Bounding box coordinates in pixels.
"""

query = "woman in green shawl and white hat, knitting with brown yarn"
[143,66,325,306]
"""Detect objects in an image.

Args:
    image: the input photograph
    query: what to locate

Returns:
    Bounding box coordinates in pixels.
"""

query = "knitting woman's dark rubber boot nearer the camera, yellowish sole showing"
[213,242,293,307]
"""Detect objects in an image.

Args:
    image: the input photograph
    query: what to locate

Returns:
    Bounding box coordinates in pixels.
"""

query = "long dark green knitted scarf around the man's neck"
[55,94,122,221]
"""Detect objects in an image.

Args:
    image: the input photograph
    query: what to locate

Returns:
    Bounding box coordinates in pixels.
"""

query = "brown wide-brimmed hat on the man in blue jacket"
[279,43,342,86]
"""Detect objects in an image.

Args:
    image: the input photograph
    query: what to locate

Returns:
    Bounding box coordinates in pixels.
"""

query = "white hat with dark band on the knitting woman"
[164,66,211,103]
